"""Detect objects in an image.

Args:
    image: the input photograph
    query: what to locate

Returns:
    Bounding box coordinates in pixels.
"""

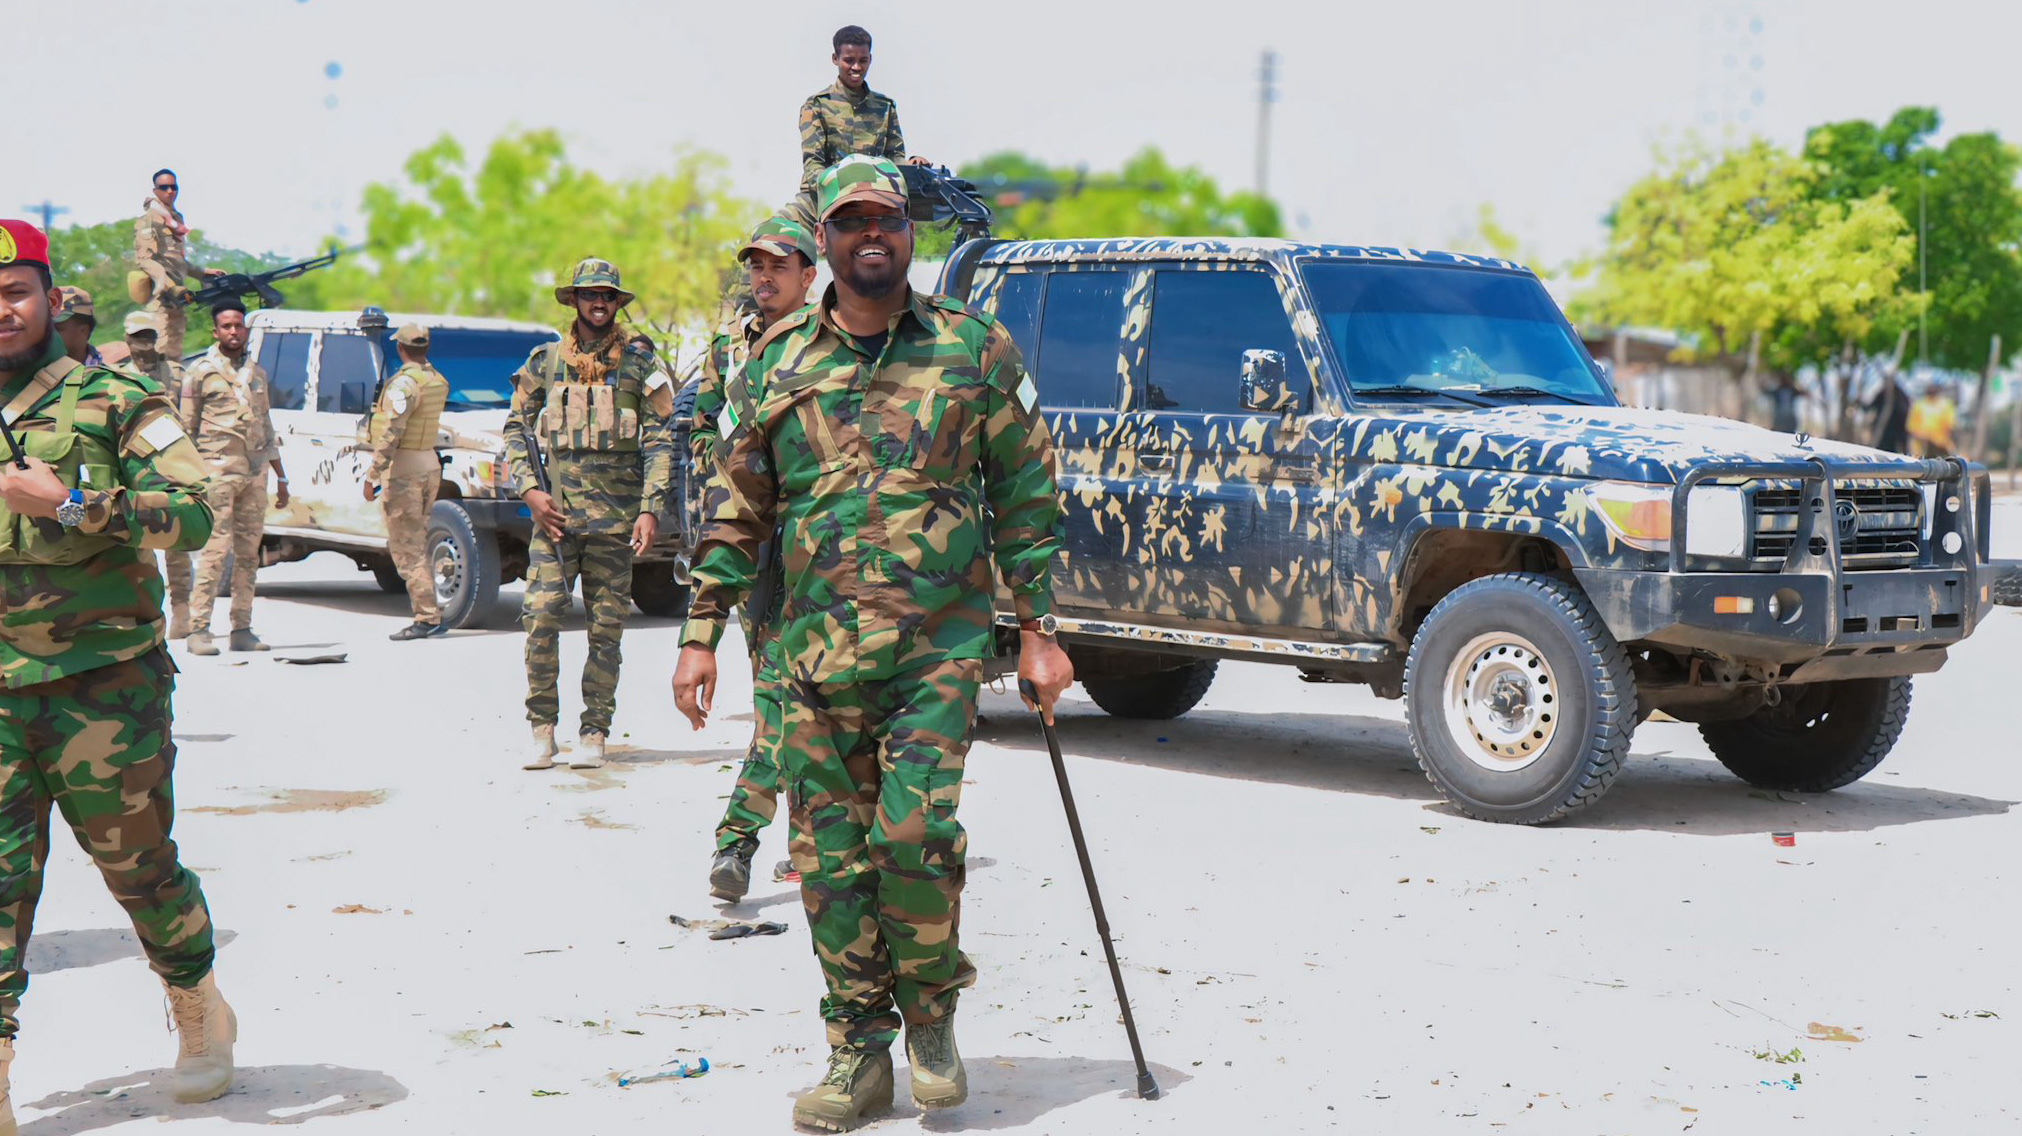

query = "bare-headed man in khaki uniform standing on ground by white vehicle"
[182,299,287,655]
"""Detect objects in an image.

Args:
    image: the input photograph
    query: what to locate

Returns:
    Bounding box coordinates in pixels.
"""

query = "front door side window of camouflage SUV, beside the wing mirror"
[1138,271,1306,414]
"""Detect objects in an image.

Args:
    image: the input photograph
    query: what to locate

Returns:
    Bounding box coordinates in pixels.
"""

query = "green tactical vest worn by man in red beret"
[0,358,119,564]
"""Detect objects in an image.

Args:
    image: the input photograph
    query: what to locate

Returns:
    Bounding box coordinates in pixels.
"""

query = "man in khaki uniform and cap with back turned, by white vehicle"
[366,323,449,641]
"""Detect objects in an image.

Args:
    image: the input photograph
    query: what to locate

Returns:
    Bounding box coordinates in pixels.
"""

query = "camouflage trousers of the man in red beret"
[0,651,214,1037]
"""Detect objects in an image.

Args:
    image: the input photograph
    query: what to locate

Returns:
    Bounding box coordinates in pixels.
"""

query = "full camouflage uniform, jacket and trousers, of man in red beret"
[0,331,212,1039]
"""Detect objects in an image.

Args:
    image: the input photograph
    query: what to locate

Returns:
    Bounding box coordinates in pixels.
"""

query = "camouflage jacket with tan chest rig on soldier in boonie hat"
[506,325,673,536]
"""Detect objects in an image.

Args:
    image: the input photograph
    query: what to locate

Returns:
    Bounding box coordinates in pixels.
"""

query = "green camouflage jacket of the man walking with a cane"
[681,291,1060,683]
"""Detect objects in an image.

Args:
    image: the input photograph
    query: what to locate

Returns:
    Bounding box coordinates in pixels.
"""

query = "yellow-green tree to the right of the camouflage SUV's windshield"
[1573,139,1923,424]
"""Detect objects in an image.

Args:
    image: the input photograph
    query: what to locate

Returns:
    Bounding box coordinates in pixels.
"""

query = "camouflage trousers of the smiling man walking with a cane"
[776,659,983,1051]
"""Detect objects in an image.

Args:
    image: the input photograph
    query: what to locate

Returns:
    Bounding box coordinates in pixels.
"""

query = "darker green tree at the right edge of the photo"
[1804,107,2022,370]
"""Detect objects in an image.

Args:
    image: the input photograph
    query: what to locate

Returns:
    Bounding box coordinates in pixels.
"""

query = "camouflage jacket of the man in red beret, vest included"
[0,338,210,689]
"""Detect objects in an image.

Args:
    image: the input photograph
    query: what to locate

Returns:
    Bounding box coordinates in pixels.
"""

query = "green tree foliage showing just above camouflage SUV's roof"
[962,148,1284,241]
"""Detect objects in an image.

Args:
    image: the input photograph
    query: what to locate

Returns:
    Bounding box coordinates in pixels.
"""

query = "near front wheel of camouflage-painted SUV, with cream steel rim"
[1403,572,1638,825]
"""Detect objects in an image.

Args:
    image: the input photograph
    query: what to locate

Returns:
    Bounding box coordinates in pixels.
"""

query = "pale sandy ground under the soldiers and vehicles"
[14,503,2022,1136]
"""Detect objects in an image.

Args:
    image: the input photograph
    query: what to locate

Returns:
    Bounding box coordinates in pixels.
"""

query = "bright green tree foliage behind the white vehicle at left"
[291,129,764,366]
